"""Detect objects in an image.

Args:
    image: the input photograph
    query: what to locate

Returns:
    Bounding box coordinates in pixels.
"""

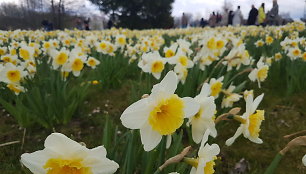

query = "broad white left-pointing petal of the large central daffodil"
[120,98,150,129]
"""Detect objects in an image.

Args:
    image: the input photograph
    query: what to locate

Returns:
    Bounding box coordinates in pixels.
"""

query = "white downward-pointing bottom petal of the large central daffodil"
[140,124,162,151]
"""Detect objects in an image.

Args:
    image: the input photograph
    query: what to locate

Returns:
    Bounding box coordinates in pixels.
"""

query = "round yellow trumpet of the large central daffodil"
[149,94,184,135]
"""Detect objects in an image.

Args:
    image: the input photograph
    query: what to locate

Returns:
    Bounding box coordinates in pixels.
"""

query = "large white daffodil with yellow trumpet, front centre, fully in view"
[120,71,200,151]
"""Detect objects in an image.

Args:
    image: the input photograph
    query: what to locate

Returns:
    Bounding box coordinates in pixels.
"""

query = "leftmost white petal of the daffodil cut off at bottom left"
[21,150,50,174]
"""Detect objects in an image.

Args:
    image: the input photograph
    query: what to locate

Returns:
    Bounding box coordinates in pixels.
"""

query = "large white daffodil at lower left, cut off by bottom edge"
[21,133,119,174]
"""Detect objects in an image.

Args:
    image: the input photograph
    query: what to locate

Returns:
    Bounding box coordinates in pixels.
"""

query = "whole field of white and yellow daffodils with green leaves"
[0,22,306,174]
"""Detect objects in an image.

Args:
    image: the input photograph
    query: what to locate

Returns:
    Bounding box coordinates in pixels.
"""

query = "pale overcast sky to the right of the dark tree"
[172,0,305,19]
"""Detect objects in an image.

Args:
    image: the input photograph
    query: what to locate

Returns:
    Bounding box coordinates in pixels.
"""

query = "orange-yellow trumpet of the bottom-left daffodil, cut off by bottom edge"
[43,158,92,174]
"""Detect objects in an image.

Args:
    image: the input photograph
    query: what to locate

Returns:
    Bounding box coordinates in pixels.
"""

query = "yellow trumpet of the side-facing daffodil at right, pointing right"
[248,110,265,137]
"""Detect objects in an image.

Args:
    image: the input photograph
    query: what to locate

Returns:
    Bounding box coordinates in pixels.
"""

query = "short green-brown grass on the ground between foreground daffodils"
[0,83,306,174]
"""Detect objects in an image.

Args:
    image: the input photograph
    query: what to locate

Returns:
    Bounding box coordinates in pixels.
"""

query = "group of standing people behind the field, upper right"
[200,0,278,27]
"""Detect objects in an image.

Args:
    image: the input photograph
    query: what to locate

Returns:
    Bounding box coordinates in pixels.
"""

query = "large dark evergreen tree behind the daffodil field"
[91,0,174,29]
